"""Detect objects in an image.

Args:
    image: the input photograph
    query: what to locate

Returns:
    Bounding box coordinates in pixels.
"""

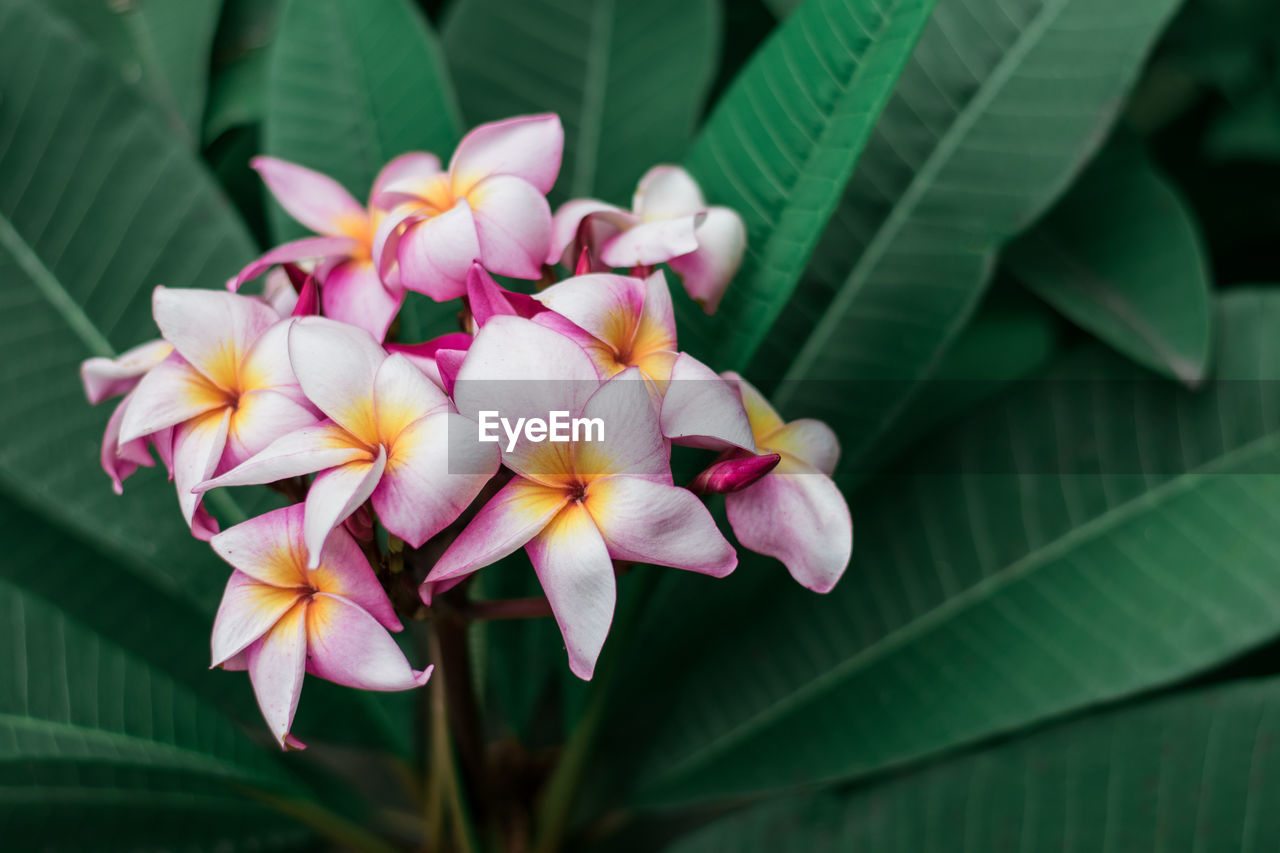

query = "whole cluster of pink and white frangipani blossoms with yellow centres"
[82,115,852,748]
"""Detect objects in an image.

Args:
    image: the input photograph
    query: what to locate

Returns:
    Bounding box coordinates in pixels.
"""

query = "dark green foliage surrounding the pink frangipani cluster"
[0,0,1280,853]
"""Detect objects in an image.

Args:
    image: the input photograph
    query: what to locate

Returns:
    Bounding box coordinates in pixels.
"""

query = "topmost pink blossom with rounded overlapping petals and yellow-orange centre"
[375,113,564,301]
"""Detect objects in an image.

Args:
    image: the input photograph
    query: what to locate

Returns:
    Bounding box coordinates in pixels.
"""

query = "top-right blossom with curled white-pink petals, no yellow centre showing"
[547,165,746,314]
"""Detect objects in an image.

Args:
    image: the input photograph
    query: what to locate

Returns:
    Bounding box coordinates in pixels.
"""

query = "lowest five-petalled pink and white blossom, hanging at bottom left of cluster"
[210,503,431,749]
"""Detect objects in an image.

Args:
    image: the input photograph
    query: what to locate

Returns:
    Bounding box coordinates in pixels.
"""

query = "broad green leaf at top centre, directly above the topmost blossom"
[443,0,719,204]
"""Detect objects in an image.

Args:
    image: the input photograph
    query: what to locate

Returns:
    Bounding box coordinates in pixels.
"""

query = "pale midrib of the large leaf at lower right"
[648,422,1280,789]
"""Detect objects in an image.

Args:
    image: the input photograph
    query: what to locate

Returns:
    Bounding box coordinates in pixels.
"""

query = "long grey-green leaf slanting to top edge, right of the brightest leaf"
[754,0,1178,459]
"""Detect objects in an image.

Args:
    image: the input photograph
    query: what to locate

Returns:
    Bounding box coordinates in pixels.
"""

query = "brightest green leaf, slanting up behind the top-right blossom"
[677,0,934,370]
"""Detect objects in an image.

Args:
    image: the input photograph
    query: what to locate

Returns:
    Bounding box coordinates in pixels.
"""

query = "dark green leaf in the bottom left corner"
[0,568,302,849]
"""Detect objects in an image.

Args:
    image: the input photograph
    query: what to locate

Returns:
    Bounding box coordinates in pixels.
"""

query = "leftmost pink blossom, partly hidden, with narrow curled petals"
[81,339,173,494]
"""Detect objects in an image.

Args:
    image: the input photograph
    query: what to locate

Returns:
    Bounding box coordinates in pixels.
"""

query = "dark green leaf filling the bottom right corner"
[666,679,1280,853]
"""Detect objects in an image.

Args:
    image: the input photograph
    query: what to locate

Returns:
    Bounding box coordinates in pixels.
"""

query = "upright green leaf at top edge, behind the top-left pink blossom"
[264,0,460,241]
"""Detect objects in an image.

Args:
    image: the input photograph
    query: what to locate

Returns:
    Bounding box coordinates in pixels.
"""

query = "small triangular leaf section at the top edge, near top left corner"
[41,0,223,146]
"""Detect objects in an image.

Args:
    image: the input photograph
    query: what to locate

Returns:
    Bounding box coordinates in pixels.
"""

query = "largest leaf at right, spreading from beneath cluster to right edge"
[602,291,1280,803]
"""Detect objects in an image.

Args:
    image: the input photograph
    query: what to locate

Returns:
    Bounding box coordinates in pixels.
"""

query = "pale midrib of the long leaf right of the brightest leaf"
[774,0,1069,397]
